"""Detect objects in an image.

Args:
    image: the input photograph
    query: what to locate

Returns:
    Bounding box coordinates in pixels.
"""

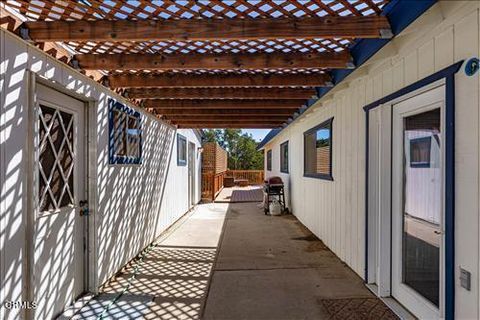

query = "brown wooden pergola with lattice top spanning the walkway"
[2,0,393,128]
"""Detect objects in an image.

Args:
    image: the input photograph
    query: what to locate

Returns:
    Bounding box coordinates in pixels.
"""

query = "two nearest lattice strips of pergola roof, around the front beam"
[3,0,388,54]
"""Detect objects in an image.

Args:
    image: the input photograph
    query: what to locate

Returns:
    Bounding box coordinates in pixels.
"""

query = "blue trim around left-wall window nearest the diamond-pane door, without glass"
[108,98,143,164]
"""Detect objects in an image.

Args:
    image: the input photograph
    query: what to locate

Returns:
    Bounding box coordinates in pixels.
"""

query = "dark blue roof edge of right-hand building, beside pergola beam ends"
[257,0,437,150]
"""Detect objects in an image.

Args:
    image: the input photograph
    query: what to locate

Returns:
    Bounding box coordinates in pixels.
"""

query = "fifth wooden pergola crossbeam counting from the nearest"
[144,99,301,110]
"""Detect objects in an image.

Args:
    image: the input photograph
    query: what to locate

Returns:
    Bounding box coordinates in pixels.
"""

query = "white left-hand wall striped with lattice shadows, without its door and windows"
[0,29,201,319]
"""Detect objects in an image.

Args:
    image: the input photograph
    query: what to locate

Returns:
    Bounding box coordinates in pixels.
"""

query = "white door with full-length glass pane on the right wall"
[392,86,445,319]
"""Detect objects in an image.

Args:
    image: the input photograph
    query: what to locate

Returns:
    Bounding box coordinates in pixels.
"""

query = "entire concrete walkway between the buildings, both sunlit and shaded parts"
[70,203,395,320]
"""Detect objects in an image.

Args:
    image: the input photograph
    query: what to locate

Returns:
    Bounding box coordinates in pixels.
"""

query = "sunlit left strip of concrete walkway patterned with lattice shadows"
[73,204,228,320]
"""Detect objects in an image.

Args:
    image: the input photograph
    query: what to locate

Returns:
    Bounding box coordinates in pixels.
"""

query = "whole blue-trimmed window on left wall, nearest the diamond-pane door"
[108,99,142,164]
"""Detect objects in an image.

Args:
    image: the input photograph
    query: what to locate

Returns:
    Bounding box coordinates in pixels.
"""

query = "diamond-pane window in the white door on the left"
[38,105,75,212]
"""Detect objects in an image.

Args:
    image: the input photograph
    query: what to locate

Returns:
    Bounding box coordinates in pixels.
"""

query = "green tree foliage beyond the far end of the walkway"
[204,129,263,170]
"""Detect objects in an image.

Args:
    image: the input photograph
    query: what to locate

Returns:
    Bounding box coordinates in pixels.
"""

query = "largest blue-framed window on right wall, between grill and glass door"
[304,118,333,180]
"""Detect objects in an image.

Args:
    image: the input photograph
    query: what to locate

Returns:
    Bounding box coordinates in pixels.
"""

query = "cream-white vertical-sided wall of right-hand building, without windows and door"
[265,1,480,319]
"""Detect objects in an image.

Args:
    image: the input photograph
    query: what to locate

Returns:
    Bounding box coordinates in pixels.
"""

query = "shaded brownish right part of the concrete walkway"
[203,203,396,320]
